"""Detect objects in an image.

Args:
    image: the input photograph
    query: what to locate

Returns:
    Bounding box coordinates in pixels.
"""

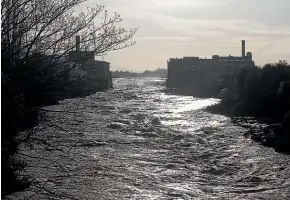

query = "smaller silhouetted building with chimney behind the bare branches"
[69,36,112,89]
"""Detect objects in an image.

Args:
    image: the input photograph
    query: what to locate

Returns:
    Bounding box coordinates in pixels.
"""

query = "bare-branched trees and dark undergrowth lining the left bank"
[1,0,137,197]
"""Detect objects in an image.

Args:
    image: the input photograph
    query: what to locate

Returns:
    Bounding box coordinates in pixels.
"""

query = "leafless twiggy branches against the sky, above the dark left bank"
[1,0,137,63]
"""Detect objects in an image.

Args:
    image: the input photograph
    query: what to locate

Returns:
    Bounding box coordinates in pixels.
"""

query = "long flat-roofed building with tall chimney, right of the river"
[167,40,255,87]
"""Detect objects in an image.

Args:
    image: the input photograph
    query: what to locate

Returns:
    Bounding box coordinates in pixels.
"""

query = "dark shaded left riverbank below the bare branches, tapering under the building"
[1,74,112,197]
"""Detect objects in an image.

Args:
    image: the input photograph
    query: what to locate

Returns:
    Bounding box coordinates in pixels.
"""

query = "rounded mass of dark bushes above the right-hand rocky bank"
[222,63,290,121]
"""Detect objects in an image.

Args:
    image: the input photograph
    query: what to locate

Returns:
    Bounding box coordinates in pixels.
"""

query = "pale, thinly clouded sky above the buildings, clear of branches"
[78,0,290,71]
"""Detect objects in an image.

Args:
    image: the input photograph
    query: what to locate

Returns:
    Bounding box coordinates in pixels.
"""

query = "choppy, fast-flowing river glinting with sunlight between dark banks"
[12,79,290,199]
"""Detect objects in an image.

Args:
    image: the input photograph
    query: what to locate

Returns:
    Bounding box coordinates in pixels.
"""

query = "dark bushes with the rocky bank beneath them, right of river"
[208,62,290,153]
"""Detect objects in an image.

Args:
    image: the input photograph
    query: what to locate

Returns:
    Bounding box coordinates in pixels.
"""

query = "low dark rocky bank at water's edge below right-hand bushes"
[206,101,290,154]
